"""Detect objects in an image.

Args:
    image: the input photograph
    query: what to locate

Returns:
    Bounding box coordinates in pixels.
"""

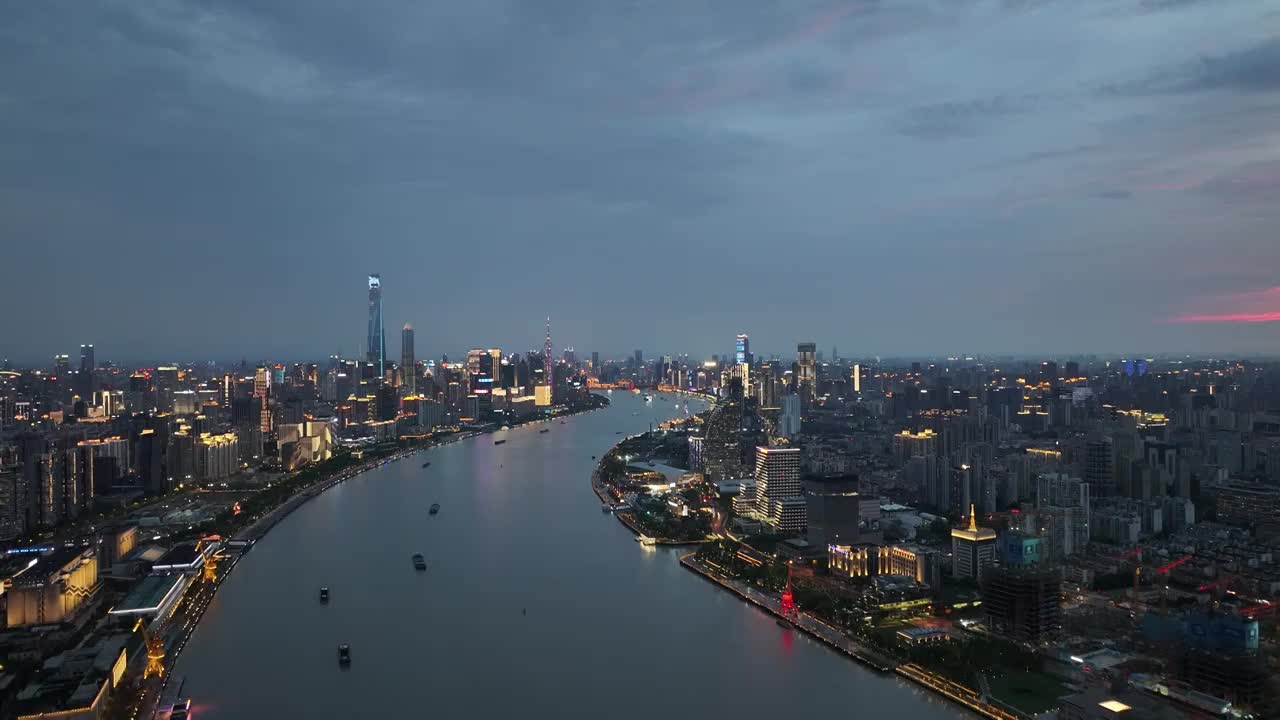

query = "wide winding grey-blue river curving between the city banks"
[177,392,965,720]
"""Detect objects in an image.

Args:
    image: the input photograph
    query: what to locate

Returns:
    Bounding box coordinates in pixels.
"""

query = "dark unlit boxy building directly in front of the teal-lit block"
[982,568,1062,644]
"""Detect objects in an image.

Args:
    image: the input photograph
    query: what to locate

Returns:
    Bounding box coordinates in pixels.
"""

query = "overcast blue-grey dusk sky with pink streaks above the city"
[0,0,1280,361]
